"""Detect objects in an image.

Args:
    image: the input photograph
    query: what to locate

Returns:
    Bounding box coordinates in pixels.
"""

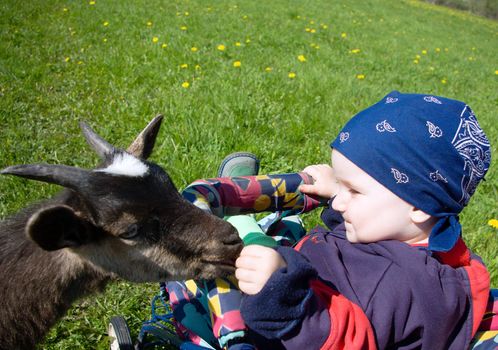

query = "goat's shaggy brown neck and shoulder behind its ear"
[0,198,110,350]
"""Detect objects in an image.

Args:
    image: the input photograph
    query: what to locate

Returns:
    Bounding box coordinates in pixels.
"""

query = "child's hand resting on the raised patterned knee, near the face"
[299,164,338,198]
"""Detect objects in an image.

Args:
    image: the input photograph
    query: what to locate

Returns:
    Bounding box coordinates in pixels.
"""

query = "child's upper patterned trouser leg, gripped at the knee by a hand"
[182,173,326,217]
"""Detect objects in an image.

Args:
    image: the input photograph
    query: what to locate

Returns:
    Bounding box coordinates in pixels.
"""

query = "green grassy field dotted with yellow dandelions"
[0,0,498,349]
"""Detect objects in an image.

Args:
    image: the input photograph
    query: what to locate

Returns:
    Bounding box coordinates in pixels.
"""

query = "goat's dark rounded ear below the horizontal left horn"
[26,205,93,251]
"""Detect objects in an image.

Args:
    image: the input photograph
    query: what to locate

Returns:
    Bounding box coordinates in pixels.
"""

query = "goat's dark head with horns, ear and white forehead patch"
[1,116,241,282]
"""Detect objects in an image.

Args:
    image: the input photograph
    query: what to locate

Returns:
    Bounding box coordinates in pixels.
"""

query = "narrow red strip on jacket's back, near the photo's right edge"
[464,259,490,336]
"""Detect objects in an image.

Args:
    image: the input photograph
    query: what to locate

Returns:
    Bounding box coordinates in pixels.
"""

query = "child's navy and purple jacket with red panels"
[241,209,489,350]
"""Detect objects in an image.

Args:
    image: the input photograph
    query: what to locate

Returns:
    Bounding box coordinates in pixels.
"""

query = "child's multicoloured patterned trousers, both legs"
[166,173,325,348]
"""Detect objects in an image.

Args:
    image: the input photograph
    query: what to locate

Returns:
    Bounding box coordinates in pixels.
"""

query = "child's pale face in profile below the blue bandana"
[332,150,422,243]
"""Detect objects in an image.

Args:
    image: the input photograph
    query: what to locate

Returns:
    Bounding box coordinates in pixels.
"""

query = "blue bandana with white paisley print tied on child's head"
[331,91,491,252]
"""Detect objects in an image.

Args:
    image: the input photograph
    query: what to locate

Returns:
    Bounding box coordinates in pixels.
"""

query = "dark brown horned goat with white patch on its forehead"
[0,116,241,349]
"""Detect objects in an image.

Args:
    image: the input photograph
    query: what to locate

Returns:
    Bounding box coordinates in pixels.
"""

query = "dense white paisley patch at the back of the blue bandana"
[451,106,491,205]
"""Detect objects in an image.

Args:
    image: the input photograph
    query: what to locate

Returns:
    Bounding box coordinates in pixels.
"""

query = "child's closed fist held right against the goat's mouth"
[235,245,287,295]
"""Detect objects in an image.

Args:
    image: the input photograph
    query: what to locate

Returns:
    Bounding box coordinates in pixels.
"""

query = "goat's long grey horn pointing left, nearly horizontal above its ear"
[0,164,88,189]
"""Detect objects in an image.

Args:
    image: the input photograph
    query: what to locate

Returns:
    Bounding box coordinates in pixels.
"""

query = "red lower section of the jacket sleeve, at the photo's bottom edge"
[311,280,377,350]
